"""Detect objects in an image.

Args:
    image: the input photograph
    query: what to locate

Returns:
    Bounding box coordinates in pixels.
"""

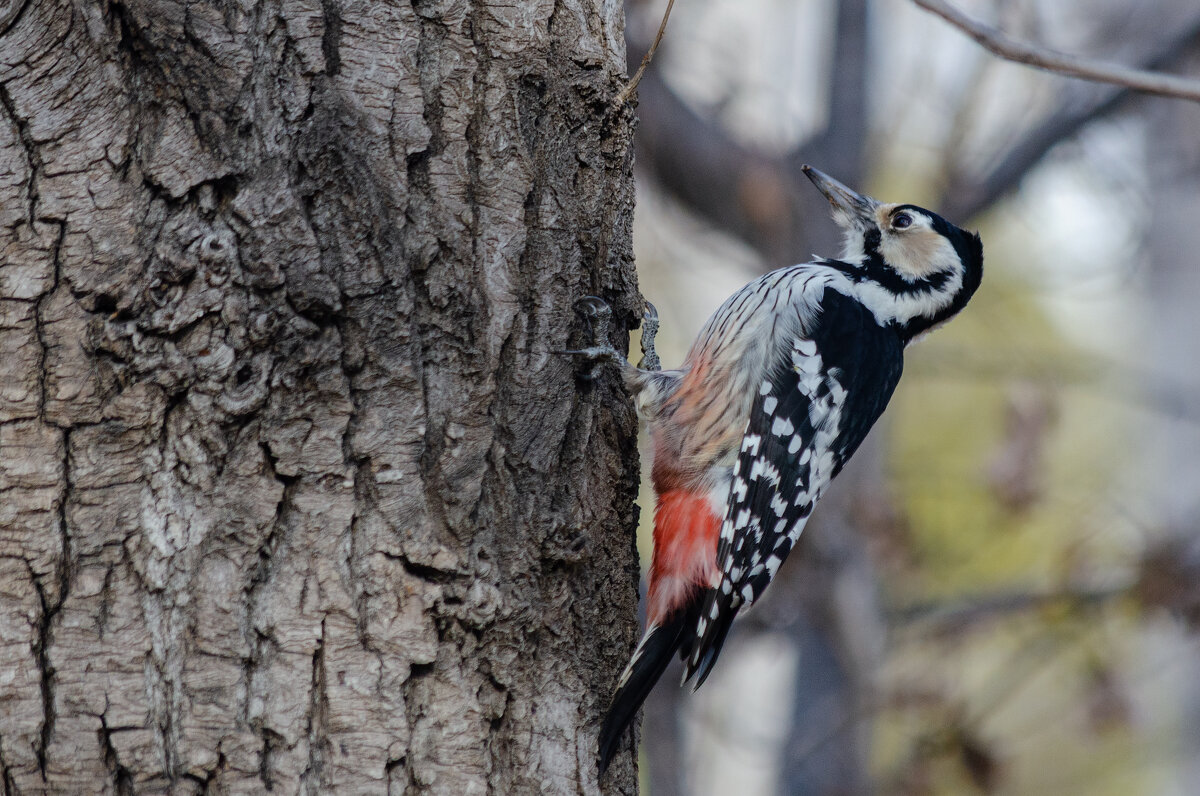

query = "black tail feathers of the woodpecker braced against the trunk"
[600,610,695,774]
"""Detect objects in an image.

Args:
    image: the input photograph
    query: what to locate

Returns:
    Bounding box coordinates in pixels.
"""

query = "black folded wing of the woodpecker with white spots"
[685,289,902,688]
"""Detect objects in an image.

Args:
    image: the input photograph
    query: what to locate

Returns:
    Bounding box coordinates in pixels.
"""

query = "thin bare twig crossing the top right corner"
[912,0,1200,102]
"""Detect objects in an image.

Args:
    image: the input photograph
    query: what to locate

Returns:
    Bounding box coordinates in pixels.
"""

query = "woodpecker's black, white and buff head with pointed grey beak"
[804,166,983,340]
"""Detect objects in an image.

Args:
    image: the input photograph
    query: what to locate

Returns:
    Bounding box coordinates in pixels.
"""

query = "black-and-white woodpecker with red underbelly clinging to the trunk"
[571,166,983,772]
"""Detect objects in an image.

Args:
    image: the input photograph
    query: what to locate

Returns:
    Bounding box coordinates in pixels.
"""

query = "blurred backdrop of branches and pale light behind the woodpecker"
[628,0,1200,796]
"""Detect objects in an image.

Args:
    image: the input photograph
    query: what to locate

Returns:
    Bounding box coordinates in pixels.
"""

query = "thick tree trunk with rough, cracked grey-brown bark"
[0,0,640,795]
